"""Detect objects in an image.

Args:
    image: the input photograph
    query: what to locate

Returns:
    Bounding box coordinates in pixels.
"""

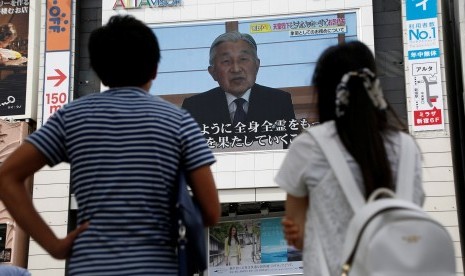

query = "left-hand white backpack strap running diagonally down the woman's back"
[307,122,366,210]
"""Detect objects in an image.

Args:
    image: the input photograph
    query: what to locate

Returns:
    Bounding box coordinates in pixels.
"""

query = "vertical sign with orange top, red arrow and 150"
[42,0,72,124]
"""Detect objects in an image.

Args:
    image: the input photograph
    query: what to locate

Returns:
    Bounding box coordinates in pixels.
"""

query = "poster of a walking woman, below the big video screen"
[208,217,303,276]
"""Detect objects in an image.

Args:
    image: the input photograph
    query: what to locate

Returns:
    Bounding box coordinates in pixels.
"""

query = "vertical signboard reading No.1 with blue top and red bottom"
[406,0,444,131]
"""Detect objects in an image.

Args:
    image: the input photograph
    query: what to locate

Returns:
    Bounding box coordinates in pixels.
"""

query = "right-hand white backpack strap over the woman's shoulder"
[396,132,416,201]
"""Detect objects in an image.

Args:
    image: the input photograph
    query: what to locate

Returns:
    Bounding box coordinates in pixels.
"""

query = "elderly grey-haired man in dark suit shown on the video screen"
[182,32,295,148]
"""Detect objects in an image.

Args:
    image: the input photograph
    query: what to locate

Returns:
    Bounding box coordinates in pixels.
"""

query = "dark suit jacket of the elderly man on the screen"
[182,84,295,149]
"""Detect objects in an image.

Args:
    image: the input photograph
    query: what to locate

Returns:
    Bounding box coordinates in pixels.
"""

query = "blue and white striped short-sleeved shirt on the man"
[27,87,215,276]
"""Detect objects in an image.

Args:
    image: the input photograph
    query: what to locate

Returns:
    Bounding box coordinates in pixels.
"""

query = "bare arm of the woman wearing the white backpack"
[282,194,308,250]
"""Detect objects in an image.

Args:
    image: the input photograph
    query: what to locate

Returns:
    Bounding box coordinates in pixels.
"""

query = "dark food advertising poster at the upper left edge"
[0,1,29,116]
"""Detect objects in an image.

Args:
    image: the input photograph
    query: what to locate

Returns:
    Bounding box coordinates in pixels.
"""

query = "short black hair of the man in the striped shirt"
[89,15,160,87]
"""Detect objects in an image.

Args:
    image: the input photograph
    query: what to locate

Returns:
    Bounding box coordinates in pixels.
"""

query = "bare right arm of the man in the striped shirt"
[188,165,221,226]
